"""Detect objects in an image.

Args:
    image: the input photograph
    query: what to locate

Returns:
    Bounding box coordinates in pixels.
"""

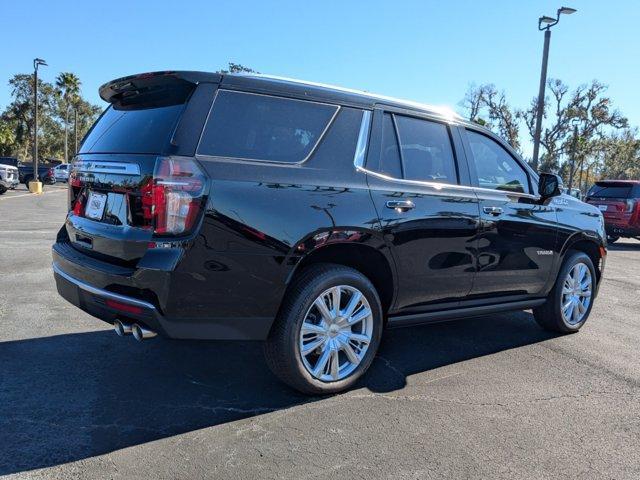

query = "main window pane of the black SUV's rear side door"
[395,115,458,183]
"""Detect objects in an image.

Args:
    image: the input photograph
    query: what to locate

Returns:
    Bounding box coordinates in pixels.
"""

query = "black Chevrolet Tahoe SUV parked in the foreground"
[53,72,606,393]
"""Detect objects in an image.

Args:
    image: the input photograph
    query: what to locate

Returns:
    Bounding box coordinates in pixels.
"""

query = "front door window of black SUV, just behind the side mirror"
[467,130,529,193]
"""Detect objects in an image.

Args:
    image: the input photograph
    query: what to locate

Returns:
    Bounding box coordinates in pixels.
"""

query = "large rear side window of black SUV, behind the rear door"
[198,91,338,163]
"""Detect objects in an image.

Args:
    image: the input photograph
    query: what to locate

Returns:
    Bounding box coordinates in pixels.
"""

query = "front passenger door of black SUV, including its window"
[461,129,557,298]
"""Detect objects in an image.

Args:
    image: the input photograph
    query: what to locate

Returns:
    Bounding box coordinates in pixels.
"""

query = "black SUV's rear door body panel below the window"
[368,174,478,310]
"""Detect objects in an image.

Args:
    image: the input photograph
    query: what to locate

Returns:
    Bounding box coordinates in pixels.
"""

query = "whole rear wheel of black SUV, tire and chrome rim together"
[264,264,382,395]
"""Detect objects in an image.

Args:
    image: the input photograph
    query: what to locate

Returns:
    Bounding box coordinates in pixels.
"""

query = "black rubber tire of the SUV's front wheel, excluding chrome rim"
[533,251,597,333]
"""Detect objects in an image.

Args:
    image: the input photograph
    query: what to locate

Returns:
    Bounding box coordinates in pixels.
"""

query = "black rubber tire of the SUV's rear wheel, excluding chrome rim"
[264,263,383,395]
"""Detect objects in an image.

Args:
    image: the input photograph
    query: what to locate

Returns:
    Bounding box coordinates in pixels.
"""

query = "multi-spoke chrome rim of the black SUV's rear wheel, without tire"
[298,285,373,382]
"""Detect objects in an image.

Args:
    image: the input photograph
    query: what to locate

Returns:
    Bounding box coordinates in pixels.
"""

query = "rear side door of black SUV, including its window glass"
[367,110,479,312]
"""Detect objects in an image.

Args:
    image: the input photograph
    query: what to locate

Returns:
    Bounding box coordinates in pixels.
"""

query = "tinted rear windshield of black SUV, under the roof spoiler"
[80,104,184,153]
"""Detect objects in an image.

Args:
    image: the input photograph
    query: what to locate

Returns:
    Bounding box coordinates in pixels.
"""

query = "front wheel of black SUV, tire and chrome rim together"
[533,252,596,333]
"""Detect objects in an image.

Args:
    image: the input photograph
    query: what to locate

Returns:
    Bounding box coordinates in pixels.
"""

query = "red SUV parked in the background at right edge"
[586,180,640,243]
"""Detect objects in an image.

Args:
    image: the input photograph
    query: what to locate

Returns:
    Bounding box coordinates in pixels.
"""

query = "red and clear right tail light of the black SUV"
[141,157,206,235]
